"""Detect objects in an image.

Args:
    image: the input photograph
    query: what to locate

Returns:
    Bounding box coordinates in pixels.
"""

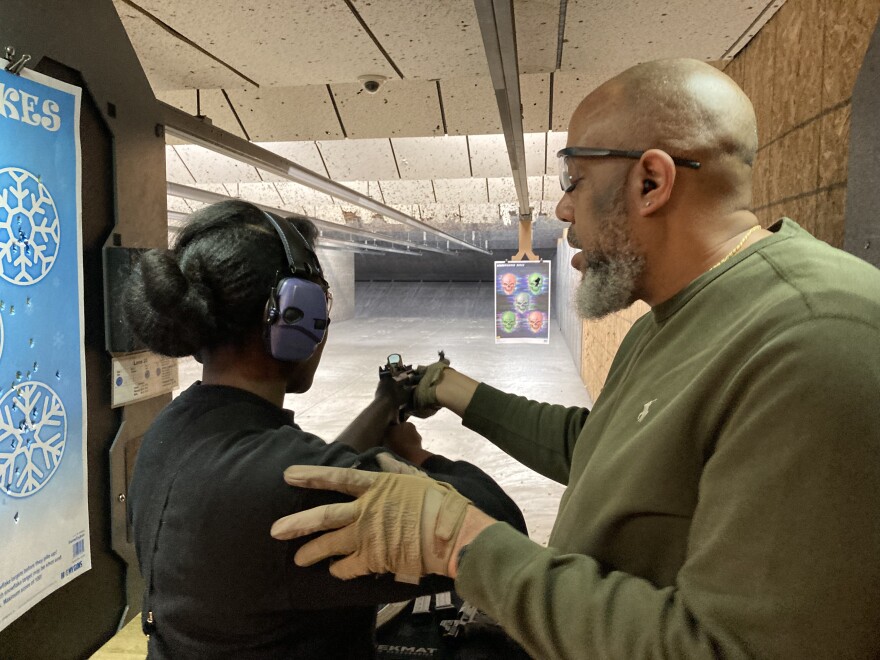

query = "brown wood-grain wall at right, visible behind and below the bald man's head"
[581,0,880,400]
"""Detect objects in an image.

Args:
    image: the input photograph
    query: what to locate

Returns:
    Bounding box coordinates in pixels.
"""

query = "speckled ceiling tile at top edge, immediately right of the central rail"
[513,0,559,74]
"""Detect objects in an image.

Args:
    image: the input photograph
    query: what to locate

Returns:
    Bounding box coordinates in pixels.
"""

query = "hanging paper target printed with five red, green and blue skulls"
[495,261,550,344]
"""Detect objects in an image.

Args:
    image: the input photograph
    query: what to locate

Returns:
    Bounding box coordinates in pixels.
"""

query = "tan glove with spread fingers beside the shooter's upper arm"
[272,465,470,584]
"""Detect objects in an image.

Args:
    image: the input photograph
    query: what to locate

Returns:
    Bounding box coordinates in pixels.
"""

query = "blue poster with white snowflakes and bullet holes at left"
[0,59,91,630]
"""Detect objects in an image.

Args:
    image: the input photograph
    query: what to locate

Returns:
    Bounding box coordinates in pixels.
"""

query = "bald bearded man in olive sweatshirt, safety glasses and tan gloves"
[273,60,880,659]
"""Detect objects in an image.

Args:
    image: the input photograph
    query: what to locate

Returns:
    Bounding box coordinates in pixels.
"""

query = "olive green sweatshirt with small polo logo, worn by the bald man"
[456,219,880,660]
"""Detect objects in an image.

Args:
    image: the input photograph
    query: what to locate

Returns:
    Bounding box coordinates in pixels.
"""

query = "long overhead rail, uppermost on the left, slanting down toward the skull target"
[158,101,492,254]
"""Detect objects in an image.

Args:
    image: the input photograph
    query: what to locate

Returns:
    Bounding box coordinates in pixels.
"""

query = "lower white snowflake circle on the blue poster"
[0,381,67,497]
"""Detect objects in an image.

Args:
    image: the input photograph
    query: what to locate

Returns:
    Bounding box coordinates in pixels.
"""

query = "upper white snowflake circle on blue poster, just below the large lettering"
[0,167,61,286]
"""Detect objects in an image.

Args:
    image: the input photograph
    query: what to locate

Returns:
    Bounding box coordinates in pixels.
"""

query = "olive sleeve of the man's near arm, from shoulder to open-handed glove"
[456,318,880,660]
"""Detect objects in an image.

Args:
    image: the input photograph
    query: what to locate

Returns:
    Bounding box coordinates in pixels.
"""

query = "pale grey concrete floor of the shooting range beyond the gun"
[180,283,591,544]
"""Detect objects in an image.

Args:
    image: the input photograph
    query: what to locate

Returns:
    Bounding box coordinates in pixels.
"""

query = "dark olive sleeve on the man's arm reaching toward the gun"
[462,383,590,484]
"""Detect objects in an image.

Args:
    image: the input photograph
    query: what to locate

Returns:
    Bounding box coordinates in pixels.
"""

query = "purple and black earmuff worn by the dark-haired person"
[264,211,330,362]
